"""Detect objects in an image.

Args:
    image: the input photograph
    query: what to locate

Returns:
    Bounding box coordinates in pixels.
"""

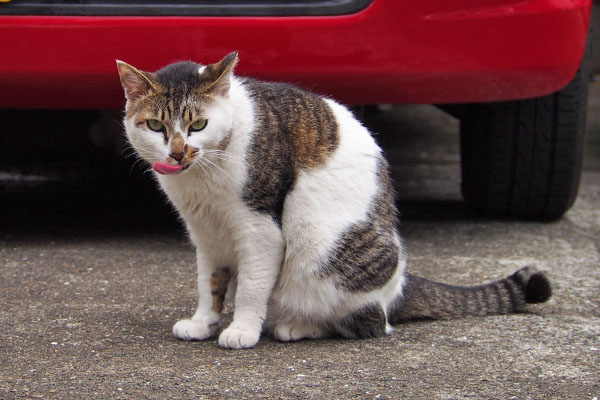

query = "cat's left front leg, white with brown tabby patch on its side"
[173,251,229,340]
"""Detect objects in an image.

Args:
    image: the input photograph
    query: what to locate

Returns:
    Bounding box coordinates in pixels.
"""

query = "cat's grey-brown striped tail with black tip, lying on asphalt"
[388,267,552,324]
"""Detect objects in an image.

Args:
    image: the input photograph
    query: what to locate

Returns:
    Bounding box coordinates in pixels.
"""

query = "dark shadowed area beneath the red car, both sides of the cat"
[0,106,480,236]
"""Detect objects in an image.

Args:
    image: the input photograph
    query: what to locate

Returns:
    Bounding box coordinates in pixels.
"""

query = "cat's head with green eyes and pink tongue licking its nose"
[117,52,238,174]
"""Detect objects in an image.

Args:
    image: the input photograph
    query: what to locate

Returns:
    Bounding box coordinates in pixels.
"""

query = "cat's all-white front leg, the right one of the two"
[219,221,285,349]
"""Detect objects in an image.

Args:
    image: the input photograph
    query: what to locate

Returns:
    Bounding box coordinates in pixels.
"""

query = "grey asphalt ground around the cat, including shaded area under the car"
[0,86,600,400]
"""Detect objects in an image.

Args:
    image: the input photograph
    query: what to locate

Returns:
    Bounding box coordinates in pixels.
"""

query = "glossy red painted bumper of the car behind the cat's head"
[0,0,591,108]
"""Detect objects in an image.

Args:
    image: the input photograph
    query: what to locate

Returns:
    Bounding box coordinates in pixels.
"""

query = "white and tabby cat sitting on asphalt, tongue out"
[117,52,551,349]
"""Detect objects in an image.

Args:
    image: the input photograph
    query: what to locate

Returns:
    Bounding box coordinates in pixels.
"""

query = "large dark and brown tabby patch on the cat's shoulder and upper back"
[243,79,339,226]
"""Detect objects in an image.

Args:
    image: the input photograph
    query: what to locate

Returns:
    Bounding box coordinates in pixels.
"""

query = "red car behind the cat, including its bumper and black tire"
[0,0,591,219]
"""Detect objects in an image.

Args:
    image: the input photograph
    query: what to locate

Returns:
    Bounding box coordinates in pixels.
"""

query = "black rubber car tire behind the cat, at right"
[460,66,589,220]
